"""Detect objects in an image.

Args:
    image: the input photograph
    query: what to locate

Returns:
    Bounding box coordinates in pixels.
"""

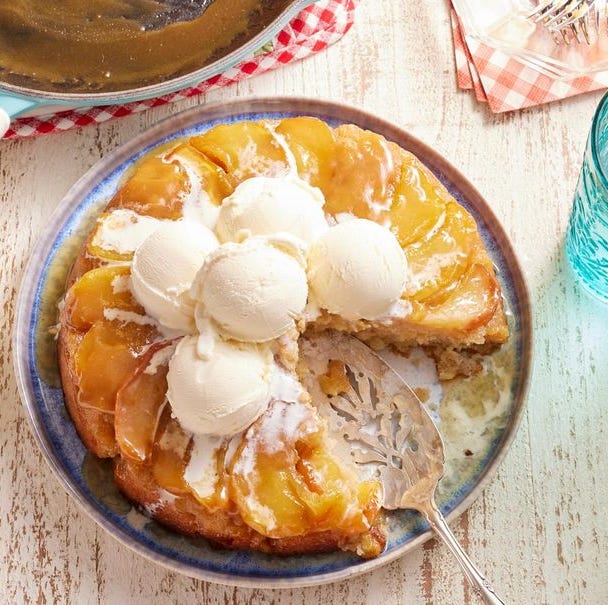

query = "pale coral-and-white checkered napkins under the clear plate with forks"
[450,7,608,113]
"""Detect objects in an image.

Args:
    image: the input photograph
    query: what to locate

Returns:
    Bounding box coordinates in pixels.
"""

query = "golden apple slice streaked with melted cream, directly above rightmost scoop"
[324,125,401,220]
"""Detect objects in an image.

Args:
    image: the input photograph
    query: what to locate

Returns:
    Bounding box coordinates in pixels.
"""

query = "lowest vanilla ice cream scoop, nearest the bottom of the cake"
[167,336,273,436]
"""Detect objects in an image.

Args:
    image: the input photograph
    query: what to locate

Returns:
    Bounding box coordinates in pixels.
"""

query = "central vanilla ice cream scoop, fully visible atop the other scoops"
[192,237,308,342]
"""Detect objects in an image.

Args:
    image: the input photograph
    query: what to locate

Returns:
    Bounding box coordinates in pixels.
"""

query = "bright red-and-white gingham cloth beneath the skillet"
[4,0,359,139]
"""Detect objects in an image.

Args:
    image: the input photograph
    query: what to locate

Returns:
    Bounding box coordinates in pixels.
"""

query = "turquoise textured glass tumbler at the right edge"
[566,95,608,303]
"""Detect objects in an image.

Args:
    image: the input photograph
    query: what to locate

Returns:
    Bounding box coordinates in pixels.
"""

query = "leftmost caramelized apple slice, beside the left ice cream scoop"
[63,266,144,331]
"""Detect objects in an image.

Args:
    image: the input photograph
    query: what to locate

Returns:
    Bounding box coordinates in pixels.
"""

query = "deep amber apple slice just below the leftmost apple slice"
[75,320,159,412]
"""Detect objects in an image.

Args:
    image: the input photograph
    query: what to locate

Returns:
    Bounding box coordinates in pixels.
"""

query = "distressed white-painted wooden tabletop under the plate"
[0,0,608,605]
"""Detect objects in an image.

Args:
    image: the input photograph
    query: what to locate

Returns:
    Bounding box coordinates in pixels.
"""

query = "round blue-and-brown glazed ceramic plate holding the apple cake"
[14,99,531,587]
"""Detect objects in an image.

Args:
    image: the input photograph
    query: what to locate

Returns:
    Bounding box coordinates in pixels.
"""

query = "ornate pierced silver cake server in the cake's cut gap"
[300,332,505,605]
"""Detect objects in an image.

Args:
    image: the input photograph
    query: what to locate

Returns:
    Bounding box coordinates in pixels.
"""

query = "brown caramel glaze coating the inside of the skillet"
[0,0,290,93]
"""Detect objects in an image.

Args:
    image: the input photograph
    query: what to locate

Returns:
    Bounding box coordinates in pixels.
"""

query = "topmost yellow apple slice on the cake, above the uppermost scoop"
[276,117,336,191]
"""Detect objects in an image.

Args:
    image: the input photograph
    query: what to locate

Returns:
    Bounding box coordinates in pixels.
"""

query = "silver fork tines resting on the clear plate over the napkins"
[527,0,607,44]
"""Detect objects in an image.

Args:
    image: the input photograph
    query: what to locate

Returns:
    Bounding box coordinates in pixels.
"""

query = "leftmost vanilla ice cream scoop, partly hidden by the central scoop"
[131,221,218,333]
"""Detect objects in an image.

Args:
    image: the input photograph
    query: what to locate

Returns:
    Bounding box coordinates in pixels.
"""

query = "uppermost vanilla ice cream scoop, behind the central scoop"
[216,176,328,244]
